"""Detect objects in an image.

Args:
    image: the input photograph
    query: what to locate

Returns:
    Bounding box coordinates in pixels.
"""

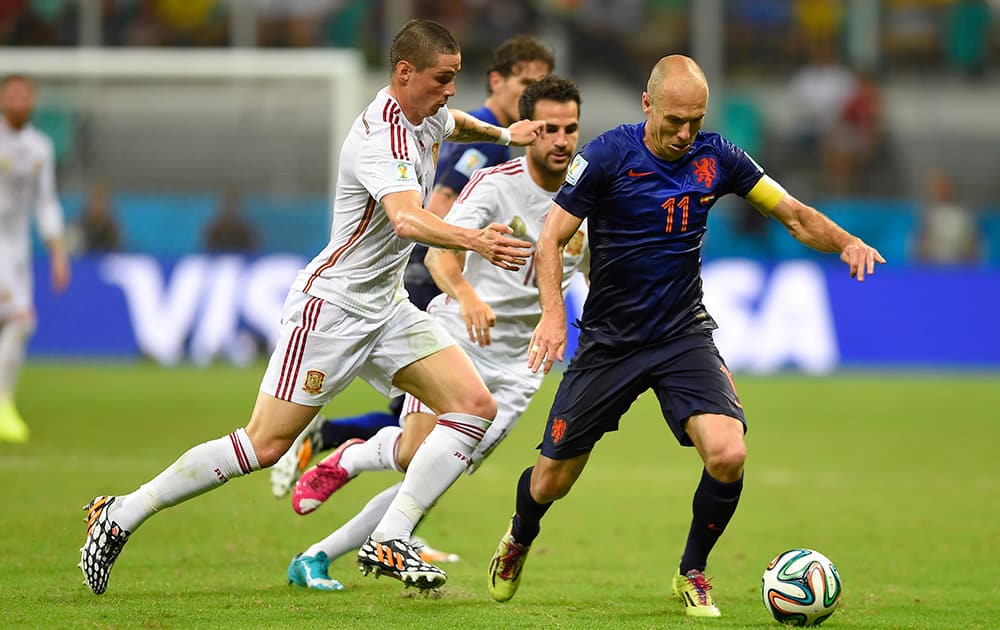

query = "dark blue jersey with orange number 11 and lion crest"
[555,123,763,344]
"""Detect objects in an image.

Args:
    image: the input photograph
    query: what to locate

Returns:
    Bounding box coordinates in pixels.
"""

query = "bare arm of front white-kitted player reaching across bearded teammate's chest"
[382,190,531,271]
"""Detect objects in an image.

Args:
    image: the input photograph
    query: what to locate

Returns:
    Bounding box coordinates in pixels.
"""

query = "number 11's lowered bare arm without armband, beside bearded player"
[528,202,583,374]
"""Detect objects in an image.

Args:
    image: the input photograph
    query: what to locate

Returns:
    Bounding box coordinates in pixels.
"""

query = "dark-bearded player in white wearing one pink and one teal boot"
[288,76,589,590]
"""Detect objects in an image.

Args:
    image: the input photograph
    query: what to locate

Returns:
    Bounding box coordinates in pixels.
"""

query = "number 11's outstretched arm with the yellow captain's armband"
[747,175,885,282]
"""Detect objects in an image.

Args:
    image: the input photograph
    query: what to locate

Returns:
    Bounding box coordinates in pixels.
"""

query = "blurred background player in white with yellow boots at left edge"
[0,75,70,442]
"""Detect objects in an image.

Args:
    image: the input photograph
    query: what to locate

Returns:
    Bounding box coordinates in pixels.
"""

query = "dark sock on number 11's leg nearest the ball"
[680,470,743,574]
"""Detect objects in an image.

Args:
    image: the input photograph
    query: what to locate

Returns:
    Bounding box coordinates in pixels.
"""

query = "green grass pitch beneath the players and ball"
[0,363,1000,629]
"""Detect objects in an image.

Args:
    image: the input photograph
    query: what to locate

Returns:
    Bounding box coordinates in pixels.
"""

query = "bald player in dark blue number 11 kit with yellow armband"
[488,55,885,617]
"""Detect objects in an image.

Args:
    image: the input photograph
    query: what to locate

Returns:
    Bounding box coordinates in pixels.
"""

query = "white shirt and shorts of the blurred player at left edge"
[0,118,63,314]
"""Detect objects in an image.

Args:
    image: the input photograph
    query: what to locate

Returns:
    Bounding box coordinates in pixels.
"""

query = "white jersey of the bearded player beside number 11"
[427,157,590,371]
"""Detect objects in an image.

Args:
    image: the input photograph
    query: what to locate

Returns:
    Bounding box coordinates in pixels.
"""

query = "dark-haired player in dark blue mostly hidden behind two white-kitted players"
[271,35,555,562]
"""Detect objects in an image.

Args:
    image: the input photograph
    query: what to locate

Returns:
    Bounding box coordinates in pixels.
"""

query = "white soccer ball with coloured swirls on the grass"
[760,549,841,626]
